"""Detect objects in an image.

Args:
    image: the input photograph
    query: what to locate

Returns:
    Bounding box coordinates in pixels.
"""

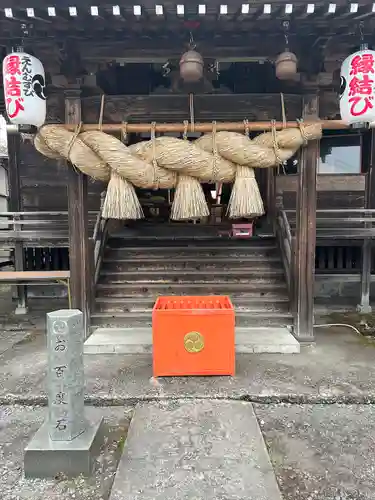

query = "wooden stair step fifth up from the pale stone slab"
[102,255,282,271]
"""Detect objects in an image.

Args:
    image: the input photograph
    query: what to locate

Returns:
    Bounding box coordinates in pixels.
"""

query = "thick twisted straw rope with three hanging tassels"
[35,108,322,219]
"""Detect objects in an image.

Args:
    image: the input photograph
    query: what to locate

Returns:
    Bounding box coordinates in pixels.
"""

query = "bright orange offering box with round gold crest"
[152,295,235,377]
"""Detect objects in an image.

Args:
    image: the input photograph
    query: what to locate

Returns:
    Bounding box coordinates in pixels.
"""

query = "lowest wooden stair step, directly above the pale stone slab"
[91,310,293,328]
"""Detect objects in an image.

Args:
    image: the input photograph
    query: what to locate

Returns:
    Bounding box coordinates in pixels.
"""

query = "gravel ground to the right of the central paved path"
[255,404,375,500]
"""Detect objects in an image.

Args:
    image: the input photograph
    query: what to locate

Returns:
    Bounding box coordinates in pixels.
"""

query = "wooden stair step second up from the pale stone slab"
[95,295,289,314]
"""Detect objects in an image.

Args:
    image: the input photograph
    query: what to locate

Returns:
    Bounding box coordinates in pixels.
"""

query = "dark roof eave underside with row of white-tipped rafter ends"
[0,0,375,61]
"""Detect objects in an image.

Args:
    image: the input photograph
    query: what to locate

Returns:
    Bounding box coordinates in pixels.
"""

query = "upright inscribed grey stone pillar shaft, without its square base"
[47,309,87,441]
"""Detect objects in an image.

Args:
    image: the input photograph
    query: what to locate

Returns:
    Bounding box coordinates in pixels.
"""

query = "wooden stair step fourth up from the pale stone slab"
[99,266,284,286]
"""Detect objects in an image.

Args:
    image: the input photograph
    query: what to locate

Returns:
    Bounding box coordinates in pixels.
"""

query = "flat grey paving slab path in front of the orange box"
[110,400,282,500]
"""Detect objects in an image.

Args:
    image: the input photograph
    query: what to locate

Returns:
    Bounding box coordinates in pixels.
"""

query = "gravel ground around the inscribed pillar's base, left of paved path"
[0,405,133,500]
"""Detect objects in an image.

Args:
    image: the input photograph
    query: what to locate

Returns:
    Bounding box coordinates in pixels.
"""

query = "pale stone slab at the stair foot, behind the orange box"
[84,327,300,354]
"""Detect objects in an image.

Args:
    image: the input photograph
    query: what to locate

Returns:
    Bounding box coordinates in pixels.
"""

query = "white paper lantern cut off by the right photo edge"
[340,49,375,125]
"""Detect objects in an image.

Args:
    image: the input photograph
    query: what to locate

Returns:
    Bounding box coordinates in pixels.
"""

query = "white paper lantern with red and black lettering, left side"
[3,52,46,127]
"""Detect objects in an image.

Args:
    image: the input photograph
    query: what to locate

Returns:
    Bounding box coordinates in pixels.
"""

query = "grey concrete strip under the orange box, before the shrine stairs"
[0,322,375,405]
